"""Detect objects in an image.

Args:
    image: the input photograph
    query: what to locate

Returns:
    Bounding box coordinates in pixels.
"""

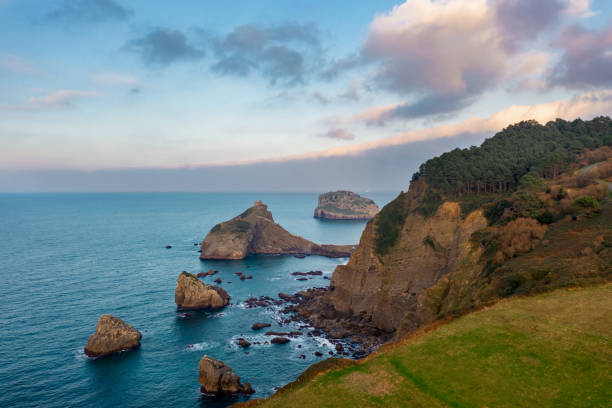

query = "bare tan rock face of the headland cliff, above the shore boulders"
[326,202,487,331]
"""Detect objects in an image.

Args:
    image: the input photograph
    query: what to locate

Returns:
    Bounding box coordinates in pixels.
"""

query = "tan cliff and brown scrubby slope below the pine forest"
[297,148,612,342]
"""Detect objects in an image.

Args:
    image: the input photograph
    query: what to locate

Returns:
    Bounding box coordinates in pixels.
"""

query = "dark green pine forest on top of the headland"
[412,116,612,196]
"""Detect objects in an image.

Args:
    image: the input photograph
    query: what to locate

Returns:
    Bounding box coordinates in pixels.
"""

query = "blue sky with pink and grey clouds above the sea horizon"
[0,0,612,192]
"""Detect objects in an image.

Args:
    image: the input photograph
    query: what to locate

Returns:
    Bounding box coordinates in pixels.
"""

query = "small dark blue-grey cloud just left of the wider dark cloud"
[124,27,205,66]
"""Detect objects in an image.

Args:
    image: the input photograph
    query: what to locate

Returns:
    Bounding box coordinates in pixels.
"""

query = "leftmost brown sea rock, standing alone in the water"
[85,315,142,357]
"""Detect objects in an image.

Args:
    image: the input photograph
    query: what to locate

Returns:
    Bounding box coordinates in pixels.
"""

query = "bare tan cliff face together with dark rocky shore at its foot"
[296,183,487,346]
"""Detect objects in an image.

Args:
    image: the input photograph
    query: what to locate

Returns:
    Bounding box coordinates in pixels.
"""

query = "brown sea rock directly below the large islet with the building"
[174,272,230,309]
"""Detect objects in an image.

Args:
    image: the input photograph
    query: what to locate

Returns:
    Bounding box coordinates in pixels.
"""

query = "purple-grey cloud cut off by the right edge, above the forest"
[548,26,612,89]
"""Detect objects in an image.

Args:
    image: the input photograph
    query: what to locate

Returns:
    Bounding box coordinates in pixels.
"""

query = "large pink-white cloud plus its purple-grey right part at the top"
[323,0,590,125]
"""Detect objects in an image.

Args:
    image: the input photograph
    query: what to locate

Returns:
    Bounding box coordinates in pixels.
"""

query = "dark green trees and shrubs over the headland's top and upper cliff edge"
[375,117,612,255]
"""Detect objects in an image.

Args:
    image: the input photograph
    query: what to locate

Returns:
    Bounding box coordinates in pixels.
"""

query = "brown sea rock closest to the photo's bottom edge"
[198,356,255,395]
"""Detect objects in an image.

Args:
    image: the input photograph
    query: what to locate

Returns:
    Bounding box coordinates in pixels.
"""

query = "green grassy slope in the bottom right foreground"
[239,284,612,407]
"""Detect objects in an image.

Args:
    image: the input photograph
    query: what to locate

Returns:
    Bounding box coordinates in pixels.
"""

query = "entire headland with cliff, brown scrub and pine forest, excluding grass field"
[286,118,612,353]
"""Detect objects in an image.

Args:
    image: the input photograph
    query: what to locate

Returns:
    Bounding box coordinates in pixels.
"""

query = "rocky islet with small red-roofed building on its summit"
[200,203,353,259]
